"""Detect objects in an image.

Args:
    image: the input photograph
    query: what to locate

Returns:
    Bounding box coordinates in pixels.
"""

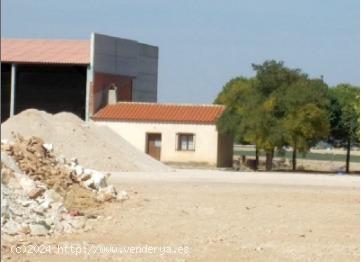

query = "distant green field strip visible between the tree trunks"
[233,149,360,163]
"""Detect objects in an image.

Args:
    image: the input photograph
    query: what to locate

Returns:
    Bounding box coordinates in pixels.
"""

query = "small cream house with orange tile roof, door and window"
[92,102,233,167]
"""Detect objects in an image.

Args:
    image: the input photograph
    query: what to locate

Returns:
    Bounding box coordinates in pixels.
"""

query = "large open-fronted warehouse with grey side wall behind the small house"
[1,33,158,121]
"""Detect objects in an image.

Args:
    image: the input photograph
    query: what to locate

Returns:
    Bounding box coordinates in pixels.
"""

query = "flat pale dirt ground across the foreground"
[3,170,360,262]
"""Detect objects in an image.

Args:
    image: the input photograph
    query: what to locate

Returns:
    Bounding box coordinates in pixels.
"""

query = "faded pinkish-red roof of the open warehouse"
[1,39,90,65]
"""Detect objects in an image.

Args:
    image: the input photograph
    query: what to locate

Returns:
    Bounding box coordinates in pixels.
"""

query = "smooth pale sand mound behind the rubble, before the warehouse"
[1,109,170,171]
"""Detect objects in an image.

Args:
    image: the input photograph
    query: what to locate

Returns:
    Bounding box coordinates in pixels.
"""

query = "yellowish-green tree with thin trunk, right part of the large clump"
[277,79,329,170]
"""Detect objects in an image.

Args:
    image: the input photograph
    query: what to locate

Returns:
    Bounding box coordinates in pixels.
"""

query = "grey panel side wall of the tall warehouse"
[93,33,158,102]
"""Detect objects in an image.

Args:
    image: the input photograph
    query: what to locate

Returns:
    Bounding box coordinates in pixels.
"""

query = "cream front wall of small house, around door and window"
[94,121,218,165]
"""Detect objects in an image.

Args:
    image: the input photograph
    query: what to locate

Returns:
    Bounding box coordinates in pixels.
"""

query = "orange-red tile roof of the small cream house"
[92,102,224,124]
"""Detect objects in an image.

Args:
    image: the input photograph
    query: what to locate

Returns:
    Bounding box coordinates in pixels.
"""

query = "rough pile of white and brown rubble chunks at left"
[1,135,128,235]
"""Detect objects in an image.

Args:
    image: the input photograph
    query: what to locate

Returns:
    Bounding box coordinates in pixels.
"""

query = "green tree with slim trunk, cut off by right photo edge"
[329,84,360,173]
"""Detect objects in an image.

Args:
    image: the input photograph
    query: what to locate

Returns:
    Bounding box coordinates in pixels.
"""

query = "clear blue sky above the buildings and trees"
[1,0,360,103]
